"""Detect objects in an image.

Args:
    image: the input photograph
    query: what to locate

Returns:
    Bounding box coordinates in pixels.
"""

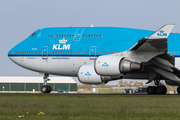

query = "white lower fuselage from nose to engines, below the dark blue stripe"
[10,57,94,76]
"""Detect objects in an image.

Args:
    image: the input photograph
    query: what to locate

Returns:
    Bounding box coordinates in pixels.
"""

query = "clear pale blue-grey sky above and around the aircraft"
[0,0,180,84]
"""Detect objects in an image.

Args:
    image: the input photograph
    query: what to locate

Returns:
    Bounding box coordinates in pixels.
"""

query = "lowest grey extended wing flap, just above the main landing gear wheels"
[153,66,180,82]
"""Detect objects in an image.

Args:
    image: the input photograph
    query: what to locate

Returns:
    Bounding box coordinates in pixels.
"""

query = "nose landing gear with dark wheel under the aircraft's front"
[41,74,51,93]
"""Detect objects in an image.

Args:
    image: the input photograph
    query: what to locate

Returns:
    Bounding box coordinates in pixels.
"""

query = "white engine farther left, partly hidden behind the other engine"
[78,64,122,84]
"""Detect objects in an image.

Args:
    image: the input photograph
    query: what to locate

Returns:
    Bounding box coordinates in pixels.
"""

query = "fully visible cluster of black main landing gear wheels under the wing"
[147,80,167,94]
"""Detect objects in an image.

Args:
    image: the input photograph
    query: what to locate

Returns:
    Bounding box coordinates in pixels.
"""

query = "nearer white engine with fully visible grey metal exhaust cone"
[94,55,143,76]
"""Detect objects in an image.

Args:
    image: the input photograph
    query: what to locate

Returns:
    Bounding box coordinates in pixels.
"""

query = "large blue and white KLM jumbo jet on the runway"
[8,24,180,94]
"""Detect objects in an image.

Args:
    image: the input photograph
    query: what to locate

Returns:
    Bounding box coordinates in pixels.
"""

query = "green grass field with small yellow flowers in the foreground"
[0,94,180,120]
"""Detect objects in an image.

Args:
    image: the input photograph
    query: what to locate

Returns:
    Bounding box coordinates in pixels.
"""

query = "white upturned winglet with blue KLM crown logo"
[148,24,174,39]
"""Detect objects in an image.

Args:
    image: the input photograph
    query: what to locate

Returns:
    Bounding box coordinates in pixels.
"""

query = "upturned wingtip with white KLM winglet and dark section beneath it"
[130,24,174,52]
